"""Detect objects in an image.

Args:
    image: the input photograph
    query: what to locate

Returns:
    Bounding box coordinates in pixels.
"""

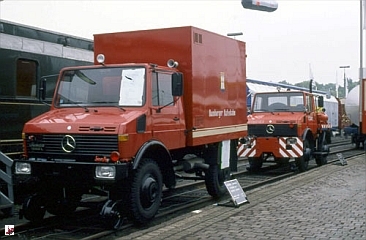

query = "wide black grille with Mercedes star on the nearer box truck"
[26,134,118,158]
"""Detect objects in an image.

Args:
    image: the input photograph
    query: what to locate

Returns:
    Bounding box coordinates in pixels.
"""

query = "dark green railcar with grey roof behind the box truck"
[0,20,93,155]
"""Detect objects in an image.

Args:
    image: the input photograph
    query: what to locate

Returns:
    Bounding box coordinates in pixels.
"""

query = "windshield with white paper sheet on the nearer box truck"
[55,67,145,107]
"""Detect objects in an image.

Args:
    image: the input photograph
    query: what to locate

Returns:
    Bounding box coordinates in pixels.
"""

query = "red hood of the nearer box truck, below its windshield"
[23,107,144,134]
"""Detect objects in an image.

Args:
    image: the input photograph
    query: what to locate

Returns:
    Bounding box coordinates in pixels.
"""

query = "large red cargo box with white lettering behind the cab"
[94,26,247,145]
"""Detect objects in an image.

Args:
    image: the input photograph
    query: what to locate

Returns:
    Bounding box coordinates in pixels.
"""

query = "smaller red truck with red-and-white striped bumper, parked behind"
[239,81,331,171]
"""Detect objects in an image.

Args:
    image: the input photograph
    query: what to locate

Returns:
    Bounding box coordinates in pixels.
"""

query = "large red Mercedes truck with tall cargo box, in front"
[15,26,247,228]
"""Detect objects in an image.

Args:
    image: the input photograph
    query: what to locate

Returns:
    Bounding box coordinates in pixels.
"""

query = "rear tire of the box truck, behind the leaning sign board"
[205,165,230,198]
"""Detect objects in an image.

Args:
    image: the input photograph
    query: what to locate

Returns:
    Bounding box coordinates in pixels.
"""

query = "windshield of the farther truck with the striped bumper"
[253,92,305,112]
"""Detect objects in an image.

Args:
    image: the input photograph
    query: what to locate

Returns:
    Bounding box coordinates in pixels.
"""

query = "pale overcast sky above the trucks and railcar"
[0,0,366,85]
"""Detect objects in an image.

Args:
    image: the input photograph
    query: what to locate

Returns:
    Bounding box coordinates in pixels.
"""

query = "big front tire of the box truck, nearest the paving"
[131,159,163,225]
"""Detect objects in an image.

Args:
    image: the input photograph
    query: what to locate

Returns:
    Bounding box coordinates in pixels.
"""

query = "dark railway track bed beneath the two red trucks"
[0,139,365,239]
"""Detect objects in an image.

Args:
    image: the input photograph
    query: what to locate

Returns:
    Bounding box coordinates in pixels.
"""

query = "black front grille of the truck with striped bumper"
[248,124,297,137]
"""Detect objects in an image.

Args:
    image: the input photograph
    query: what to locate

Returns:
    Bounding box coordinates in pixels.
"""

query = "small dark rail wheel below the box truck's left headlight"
[22,195,46,223]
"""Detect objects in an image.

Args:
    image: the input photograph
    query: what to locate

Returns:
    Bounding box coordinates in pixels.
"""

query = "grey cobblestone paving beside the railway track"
[118,155,366,240]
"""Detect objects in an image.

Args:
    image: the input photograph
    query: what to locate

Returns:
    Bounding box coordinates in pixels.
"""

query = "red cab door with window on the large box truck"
[151,72,185,149]
